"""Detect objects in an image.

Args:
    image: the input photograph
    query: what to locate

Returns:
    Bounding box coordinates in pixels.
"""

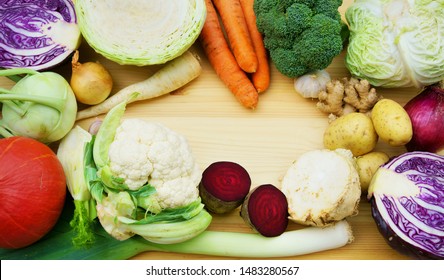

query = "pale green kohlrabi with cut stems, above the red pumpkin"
[0,68,77,143]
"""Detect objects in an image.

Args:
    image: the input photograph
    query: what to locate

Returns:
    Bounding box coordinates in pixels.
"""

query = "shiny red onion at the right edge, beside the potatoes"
[404,81,444,155]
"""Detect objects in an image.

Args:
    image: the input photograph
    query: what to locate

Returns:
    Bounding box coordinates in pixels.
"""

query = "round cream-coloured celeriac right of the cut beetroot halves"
[280,149,361,227]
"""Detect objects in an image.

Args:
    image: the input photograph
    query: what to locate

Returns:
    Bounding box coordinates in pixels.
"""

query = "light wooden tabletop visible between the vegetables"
[0,0,419,260]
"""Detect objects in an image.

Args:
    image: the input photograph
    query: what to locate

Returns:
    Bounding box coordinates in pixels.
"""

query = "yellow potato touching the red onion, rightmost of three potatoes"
[371,99,413,147]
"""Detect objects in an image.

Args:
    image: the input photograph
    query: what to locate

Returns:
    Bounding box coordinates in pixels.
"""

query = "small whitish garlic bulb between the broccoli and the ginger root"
[294,70,331,98]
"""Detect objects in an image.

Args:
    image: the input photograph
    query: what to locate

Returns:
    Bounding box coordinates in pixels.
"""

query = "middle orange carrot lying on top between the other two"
[212,0,258,73]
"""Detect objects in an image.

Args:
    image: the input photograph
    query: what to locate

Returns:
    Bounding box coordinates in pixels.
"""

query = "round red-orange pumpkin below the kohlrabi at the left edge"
[0,136,66,249]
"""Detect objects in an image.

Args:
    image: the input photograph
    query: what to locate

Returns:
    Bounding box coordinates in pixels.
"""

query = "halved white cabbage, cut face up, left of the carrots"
[75,0,206,66]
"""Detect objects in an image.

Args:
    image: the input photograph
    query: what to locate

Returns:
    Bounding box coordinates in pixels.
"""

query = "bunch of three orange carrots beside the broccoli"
[199,0,270,109]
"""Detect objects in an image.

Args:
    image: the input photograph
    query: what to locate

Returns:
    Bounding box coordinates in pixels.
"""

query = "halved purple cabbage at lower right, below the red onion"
[368,152,444,259]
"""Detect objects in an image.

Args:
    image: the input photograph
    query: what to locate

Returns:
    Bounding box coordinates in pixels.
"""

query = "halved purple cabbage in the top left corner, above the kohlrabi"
[0,0,81,70]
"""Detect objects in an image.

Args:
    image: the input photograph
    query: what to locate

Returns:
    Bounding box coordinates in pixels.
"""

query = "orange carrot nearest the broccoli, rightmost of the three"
[239,0,270,93]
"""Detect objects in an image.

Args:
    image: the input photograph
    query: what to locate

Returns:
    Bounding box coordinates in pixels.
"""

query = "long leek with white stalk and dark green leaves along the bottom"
[0,201,353,260]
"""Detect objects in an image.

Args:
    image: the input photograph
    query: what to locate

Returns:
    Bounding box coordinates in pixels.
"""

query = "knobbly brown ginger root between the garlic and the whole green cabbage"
[316,78,382,120]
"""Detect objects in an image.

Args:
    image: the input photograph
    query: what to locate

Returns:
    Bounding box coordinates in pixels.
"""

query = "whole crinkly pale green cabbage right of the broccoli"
[345,0,444,87]
